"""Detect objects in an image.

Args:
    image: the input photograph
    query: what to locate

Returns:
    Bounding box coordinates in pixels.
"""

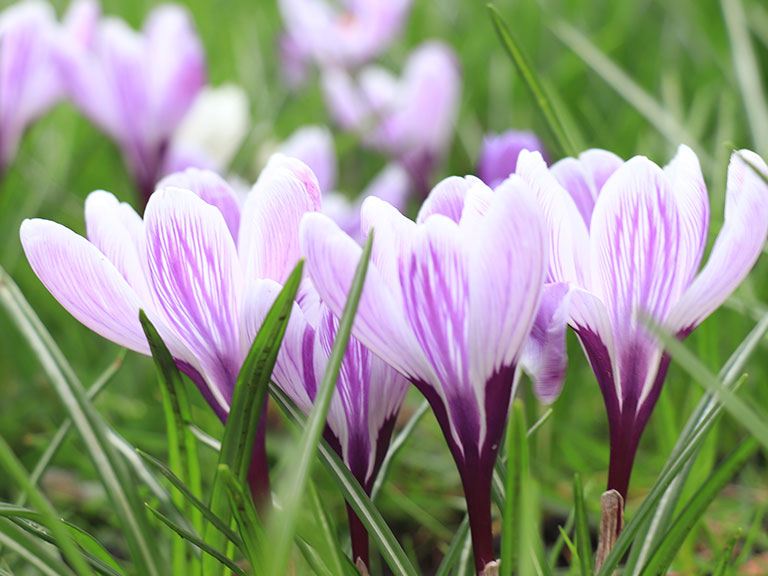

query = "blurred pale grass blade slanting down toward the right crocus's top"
[550,21,710,164]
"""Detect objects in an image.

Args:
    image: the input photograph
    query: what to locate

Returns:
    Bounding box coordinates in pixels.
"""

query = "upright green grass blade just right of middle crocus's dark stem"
[501,400,528,576]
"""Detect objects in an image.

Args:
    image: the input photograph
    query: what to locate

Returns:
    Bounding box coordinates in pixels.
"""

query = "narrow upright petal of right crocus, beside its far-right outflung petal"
[664,146,709,285]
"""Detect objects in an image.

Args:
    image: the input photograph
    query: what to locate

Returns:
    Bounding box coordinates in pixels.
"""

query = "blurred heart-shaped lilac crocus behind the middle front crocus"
[323,41,461,195]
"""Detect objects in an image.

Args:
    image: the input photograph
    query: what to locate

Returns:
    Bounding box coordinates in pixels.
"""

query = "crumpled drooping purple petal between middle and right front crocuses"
[520,283,569,404]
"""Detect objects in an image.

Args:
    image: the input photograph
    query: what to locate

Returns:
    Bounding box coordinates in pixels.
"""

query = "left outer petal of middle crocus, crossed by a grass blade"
[300,214,432,380]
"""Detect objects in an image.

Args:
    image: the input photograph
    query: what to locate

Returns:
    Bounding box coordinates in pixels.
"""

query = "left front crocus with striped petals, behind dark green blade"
[21,157,320,501]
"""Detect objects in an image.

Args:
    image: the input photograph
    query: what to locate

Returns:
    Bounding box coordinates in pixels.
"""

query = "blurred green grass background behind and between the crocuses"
[0,0,768,574]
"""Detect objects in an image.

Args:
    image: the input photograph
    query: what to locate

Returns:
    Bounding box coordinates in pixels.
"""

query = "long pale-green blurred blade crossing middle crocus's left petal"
[264,232,374,576]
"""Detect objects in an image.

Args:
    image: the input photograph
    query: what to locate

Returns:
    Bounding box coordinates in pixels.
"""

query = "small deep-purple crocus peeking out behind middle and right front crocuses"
[477,130,547,187]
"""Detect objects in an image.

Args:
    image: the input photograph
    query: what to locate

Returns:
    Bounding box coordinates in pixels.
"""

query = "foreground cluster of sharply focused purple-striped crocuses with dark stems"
[21,141,768,571]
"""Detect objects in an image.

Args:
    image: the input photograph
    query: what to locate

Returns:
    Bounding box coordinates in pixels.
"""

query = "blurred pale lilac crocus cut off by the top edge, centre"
[278,0,412,74]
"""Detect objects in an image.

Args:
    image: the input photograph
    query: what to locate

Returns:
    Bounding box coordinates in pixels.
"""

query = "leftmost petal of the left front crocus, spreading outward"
[20,219,149,354]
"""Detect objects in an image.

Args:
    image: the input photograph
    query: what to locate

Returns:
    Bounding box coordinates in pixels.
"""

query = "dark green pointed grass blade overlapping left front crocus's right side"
[203,261,304,574]
